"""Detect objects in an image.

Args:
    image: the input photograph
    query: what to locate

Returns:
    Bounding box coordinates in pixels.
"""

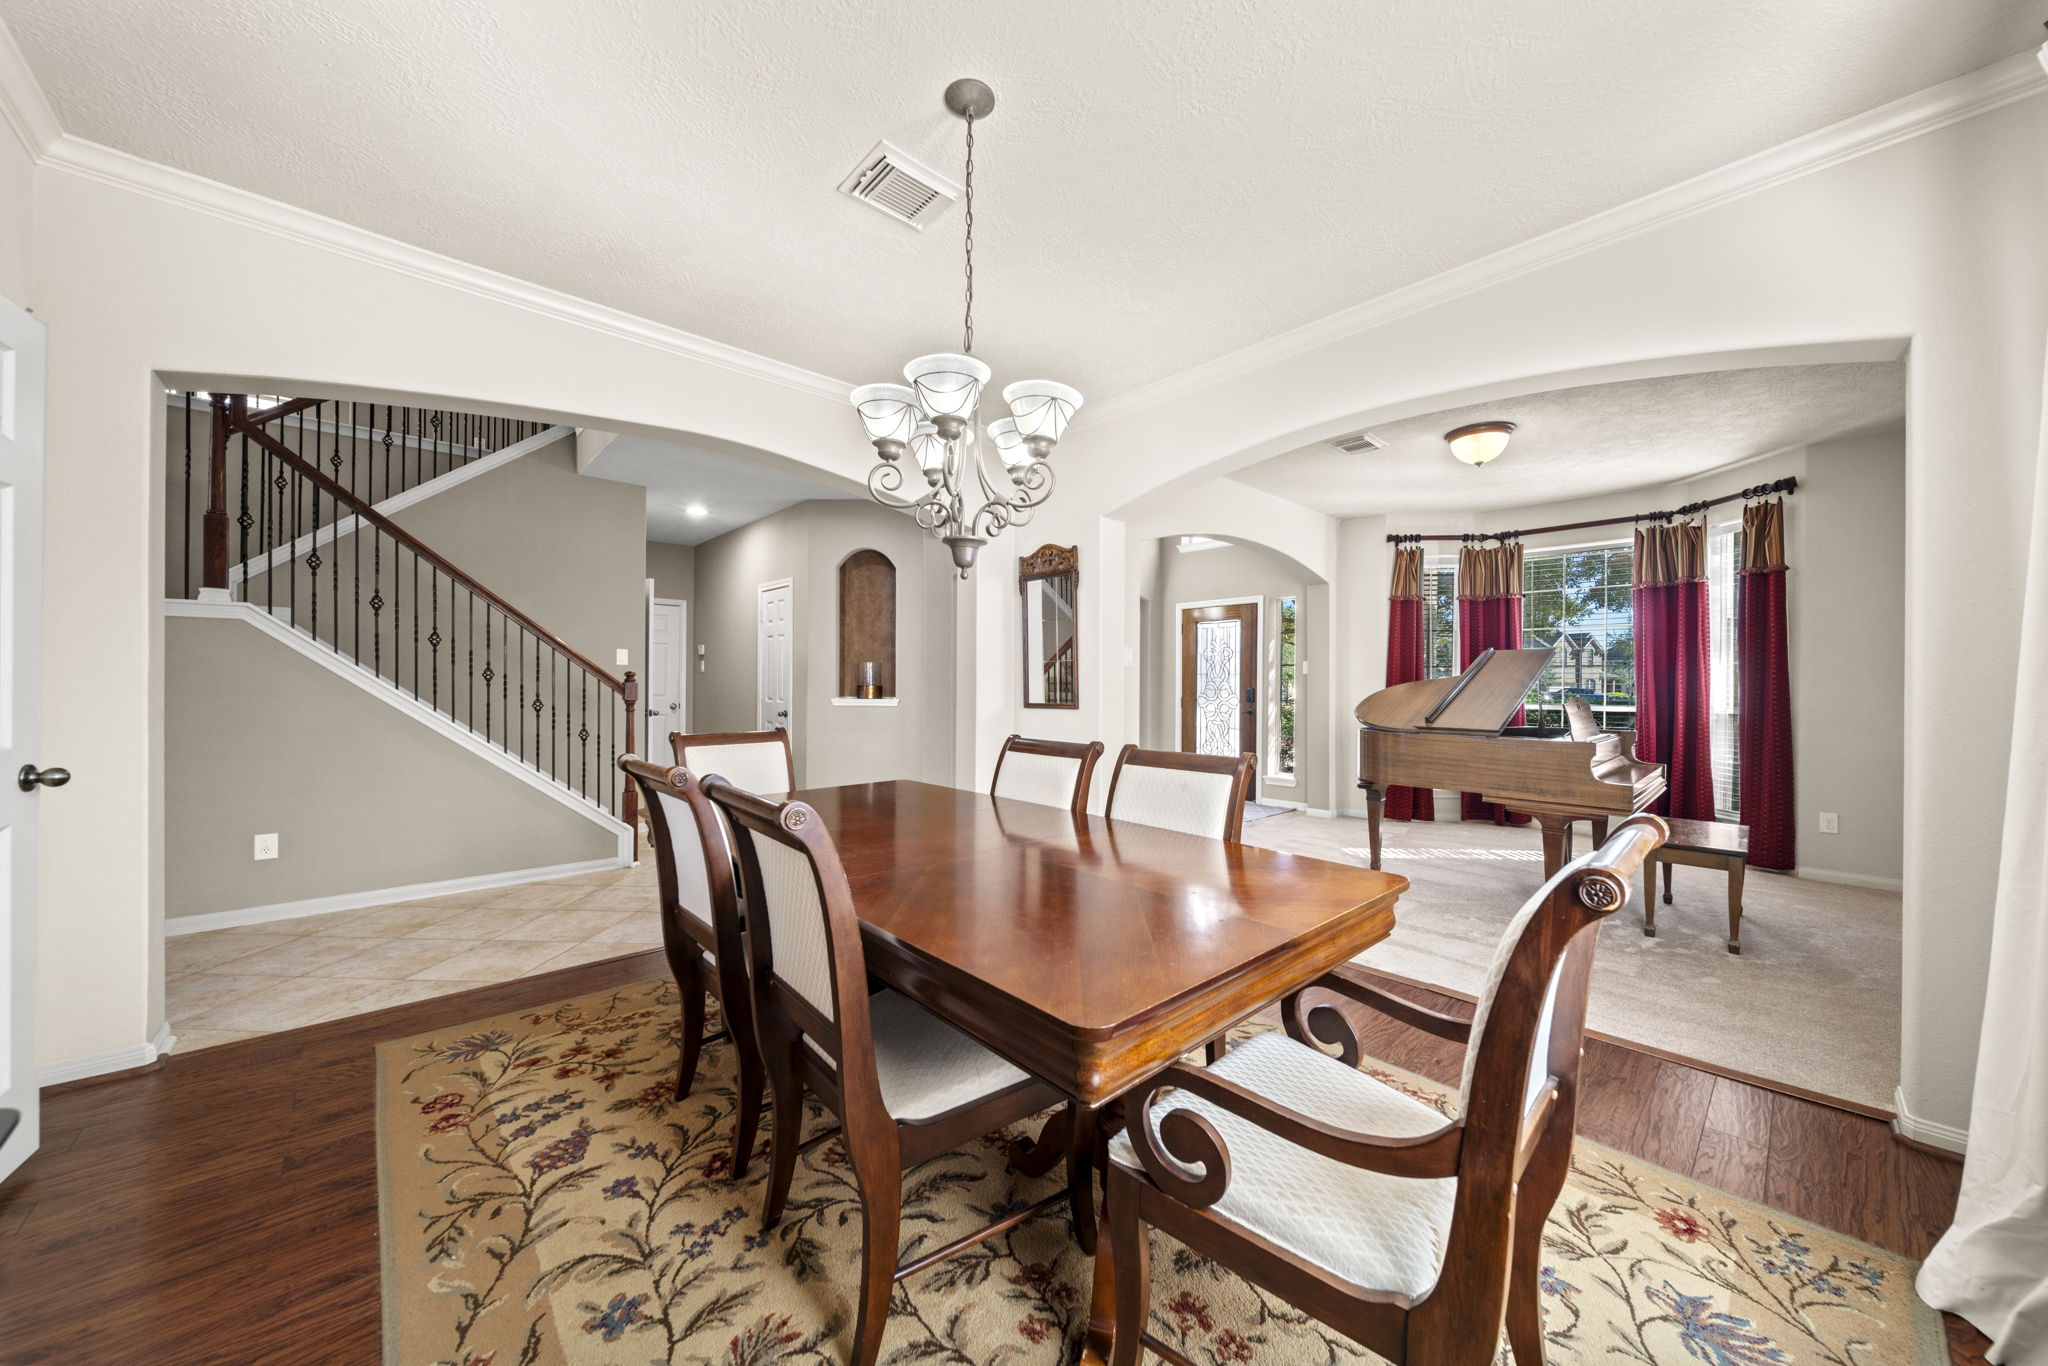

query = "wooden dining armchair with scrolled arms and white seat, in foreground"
[1098,815,1665,1366]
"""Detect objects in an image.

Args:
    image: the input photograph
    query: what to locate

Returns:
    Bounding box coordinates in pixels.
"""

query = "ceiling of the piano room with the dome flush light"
[1231,360,1907,516]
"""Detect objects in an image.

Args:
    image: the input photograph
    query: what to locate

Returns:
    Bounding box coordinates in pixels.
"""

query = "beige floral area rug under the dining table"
[379,981,1948,1366]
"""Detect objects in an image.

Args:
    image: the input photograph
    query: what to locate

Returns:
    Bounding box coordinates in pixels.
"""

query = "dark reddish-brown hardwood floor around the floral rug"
[0,952,1987,1366]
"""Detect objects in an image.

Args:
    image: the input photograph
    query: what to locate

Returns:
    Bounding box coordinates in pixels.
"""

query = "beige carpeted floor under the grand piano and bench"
[1245,811,1898,1112]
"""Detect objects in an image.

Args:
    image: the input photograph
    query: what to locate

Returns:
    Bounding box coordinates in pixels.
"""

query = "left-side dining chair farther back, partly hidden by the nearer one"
[618,754,766,1180]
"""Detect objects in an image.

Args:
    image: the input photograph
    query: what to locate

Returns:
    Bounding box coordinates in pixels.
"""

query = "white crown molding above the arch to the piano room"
[1073,45,2048,426]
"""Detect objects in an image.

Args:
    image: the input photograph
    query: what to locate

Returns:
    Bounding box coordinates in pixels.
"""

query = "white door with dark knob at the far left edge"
[0,299,48,1180]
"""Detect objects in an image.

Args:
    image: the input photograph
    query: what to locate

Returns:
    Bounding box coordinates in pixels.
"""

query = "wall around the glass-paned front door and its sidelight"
[1139,539,1331,811]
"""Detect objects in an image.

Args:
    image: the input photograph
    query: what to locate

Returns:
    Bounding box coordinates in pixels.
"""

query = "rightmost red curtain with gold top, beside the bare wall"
[1735,498,1798,870]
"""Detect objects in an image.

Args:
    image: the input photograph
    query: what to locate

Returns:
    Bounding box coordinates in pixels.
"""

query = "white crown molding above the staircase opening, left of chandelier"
[39,136,852,403]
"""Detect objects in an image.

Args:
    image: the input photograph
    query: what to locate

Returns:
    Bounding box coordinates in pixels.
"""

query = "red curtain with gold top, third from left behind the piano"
[1632,522,1714,821]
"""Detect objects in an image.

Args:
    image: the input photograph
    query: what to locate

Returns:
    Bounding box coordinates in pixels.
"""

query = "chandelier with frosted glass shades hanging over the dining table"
[852,80,1081,580]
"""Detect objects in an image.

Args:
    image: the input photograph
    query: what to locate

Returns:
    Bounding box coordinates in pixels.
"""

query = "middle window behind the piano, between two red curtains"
[1522,541,1636,729]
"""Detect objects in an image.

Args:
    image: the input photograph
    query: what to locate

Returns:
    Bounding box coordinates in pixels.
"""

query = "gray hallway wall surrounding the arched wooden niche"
[690,500,954,786]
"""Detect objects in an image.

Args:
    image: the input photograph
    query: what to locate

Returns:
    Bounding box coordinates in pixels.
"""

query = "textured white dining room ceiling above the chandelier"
[0,0,2040,399]
